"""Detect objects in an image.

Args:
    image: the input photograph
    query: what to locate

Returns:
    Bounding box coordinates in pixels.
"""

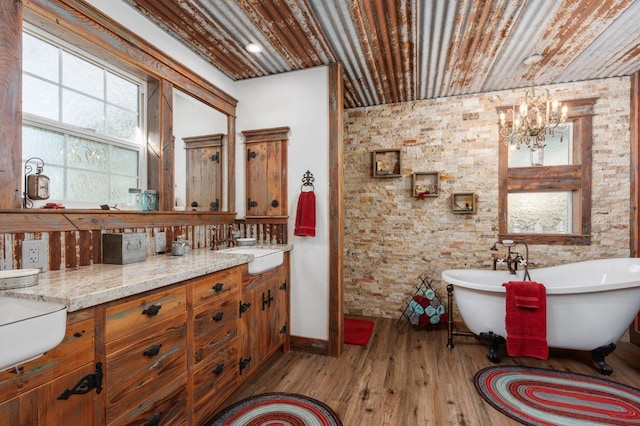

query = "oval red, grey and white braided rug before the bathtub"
[474,366,640,426]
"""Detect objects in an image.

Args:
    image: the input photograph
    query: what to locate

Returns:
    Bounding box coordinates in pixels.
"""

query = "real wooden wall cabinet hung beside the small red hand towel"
[242,127,289,217]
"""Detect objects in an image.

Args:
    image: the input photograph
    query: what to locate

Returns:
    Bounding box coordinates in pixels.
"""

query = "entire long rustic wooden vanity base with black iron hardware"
[0,253,289,426]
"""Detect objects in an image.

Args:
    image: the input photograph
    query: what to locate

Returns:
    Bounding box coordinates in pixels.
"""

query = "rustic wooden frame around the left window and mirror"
[0,0,238,214]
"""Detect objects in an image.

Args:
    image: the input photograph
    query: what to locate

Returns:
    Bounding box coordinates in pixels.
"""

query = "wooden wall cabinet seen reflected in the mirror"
[182,133,224,212]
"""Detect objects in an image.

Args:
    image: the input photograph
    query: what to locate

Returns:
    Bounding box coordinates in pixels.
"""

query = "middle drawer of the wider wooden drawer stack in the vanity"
[105,312,187,421]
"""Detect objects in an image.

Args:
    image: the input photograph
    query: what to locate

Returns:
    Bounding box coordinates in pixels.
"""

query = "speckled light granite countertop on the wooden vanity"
[0,245,292,312]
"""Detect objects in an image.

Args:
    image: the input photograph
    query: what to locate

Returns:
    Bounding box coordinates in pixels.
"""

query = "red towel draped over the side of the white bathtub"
[502,281,549,359]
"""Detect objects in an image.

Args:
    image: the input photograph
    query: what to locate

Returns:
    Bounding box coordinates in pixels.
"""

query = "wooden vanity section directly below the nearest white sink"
[0,309,97,426]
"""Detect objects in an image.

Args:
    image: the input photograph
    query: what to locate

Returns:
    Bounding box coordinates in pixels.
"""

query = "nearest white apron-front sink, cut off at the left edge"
[0,297,67,372]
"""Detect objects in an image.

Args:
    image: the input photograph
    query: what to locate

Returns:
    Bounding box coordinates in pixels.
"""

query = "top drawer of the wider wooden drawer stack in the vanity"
[105,286,187,342]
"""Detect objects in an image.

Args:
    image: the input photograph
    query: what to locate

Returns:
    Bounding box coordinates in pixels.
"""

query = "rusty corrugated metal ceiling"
[122,0,640,108]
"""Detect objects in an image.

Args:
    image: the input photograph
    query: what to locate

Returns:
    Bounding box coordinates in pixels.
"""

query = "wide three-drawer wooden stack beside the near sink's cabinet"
[105,285,188,425]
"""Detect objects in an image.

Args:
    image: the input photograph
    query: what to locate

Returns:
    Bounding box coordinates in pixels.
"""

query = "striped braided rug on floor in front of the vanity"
[209,393,342,426]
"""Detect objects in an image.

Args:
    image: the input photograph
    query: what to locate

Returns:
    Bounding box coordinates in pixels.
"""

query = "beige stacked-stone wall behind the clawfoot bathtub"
[344,78,631,318]
